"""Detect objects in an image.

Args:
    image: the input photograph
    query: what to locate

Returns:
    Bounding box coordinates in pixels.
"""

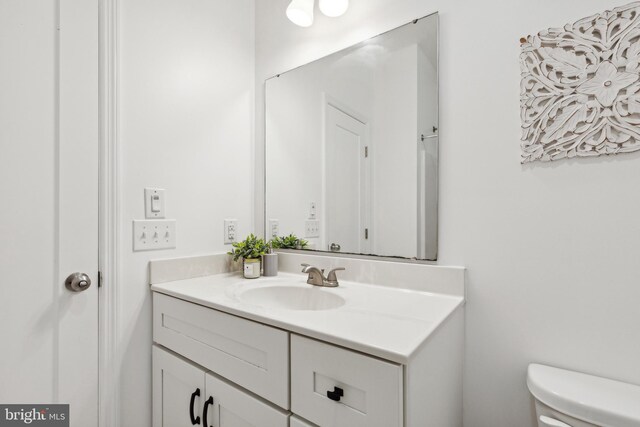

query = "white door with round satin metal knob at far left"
[0,0,99,427]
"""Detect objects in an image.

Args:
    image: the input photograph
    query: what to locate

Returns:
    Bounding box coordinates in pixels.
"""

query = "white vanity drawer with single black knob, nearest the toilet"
[291,335,403,427]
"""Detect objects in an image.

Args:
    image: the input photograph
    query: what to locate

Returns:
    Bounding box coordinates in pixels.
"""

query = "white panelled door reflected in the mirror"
[324,104,371,253]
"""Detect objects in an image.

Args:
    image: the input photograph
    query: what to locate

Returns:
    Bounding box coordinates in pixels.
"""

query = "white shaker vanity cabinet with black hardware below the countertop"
[153,292,464,427]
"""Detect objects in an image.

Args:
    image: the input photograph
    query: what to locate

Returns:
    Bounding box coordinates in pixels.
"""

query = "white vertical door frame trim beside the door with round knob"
[98,0,121,427]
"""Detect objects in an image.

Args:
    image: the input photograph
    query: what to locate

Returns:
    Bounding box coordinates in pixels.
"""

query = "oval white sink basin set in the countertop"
[239,286,345,311]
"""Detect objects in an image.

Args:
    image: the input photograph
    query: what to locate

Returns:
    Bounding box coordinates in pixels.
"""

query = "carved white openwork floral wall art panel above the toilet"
[520,2,640,163]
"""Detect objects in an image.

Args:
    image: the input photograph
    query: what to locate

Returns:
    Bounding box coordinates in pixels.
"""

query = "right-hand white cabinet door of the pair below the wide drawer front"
[204,374,289,427]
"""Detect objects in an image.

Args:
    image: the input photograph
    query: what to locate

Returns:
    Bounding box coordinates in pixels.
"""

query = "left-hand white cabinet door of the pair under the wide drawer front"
[153,345,205,427]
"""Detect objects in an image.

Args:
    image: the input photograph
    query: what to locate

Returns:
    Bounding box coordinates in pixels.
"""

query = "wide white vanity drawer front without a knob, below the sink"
[153,292,289,409]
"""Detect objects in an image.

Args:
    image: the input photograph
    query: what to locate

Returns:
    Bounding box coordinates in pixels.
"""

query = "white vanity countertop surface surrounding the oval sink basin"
[151,273,464,364]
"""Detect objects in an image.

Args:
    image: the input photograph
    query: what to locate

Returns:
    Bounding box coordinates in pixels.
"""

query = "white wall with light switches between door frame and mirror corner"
[119,0,254,427]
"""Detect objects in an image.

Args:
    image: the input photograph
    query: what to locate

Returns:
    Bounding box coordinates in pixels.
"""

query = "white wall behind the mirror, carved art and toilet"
[256,0,640,427]
